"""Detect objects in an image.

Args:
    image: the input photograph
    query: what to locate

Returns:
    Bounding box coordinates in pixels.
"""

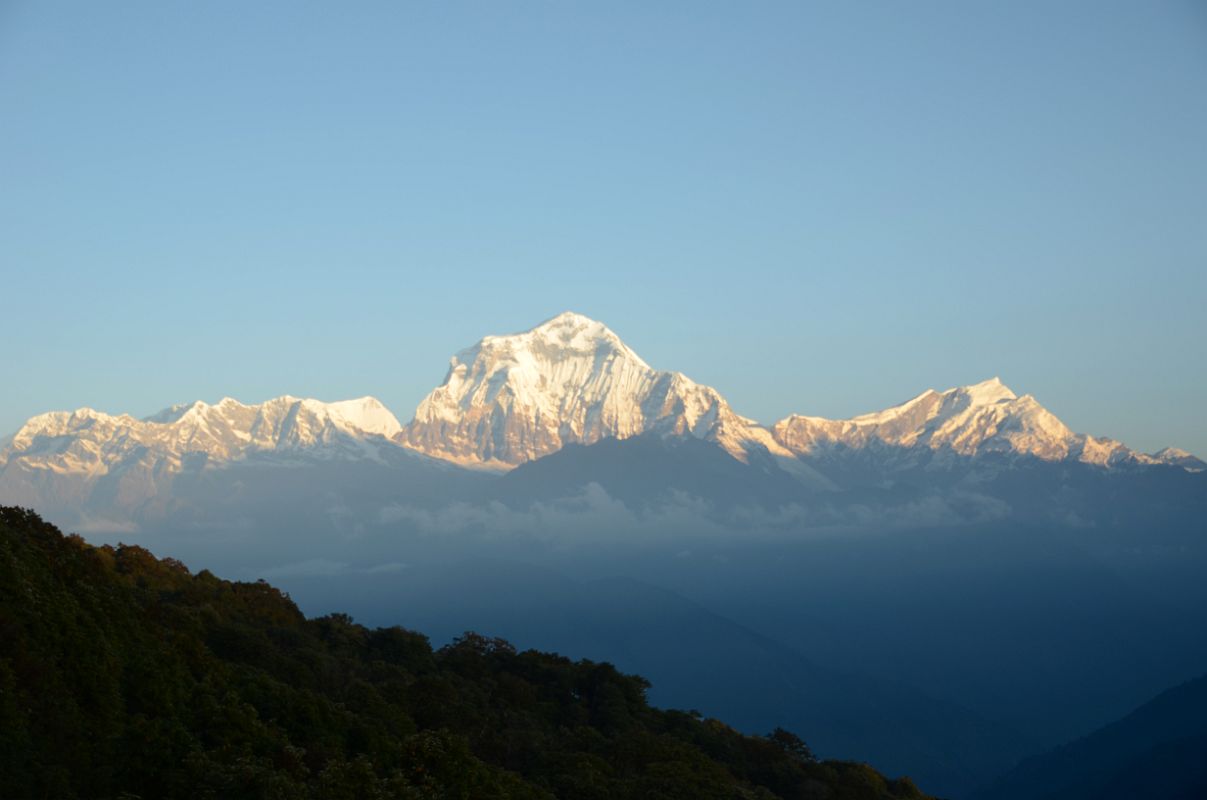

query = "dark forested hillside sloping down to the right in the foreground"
[0,507,925,800]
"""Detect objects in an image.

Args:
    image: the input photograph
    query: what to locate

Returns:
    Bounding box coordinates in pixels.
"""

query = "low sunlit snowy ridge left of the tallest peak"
[0,396,402,475]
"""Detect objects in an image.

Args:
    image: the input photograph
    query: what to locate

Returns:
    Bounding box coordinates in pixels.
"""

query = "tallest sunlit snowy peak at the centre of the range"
[397,311,787,468]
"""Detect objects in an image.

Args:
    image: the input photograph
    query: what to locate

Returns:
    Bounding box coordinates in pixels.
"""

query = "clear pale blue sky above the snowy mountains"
[0,0,1207,455]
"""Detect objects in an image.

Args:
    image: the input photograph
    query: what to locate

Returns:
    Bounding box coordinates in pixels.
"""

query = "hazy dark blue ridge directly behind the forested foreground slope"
[282,559,1042,798]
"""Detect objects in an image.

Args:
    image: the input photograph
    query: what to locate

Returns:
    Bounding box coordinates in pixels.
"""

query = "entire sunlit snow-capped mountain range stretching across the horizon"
[0,313,1207,492]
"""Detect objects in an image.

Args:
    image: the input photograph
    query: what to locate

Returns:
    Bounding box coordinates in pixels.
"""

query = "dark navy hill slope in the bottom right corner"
[975,676,1207,800]
